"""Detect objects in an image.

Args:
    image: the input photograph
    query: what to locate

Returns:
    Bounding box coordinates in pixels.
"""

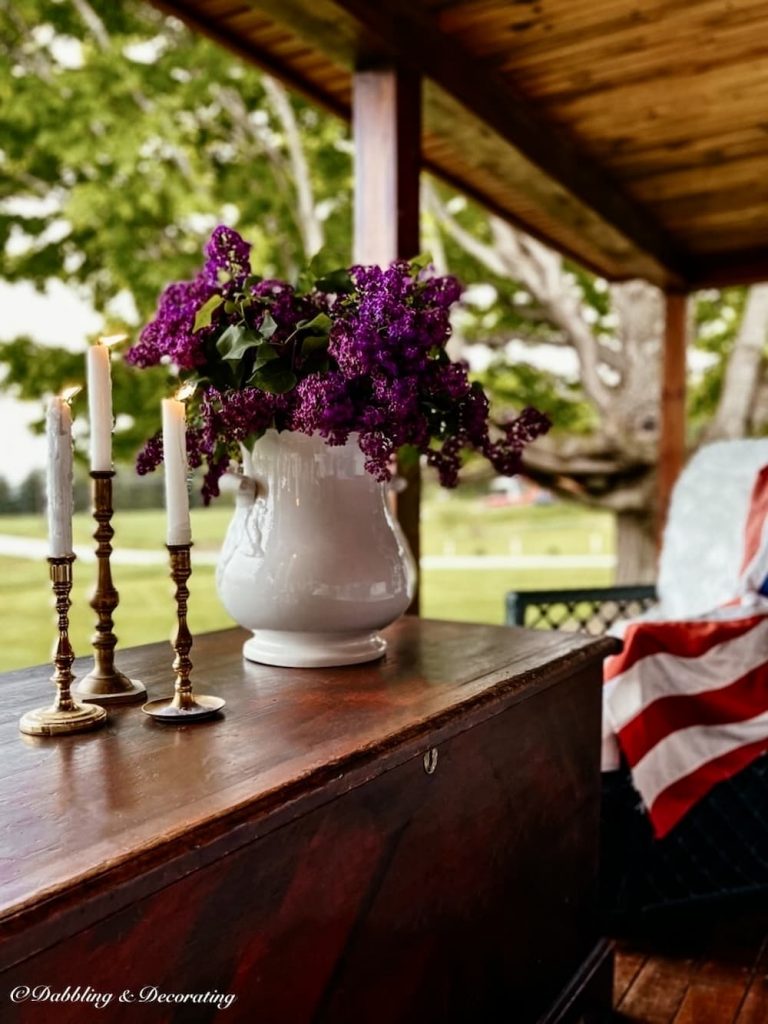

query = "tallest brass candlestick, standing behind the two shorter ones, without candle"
[75,470,146,705]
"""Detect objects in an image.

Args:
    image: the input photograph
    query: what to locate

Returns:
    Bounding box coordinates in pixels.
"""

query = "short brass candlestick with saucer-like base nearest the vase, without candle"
[141,544,224,723]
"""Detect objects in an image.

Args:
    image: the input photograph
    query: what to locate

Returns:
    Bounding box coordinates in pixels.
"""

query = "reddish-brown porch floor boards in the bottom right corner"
[613,911,768,1024]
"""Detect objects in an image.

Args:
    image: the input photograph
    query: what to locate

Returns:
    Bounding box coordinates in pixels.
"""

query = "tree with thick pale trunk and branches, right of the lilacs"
[424,183,768,582]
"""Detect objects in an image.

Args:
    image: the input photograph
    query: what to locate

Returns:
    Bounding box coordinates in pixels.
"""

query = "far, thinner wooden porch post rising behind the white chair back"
[656,292,687,544]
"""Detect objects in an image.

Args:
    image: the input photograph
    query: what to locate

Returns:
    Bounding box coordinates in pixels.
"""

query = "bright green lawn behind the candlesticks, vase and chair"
[0,490,613,671]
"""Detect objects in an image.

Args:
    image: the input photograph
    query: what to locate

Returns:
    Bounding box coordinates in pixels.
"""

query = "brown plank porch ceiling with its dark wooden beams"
[154,0,768,289]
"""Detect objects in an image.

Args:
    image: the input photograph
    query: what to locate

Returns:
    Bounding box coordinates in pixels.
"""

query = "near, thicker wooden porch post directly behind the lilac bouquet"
[352,67,421,613]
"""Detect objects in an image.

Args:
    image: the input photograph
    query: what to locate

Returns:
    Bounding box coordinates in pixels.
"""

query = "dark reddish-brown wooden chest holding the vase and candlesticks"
[0,618,614,1024]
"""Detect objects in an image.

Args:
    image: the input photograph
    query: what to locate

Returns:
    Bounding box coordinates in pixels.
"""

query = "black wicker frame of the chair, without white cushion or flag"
[507,586,768,929]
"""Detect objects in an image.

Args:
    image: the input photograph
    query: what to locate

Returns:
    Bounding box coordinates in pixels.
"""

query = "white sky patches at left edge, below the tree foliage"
[0,281,101,483]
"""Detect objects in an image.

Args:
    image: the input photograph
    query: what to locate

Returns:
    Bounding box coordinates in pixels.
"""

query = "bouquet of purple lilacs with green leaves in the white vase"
[128,226,549,503]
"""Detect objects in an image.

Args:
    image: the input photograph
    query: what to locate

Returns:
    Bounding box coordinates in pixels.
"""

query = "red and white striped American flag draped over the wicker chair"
[603,467,768,839]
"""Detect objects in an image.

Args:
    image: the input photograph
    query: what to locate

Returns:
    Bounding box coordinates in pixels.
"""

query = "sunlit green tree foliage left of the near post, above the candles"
[0,0,351,457]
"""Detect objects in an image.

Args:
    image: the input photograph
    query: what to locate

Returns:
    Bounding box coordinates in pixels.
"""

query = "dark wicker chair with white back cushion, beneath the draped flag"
[507,440,768,930]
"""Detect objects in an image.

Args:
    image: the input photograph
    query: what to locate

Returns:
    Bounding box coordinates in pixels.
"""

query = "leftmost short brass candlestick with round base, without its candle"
[18,555,106,736]
